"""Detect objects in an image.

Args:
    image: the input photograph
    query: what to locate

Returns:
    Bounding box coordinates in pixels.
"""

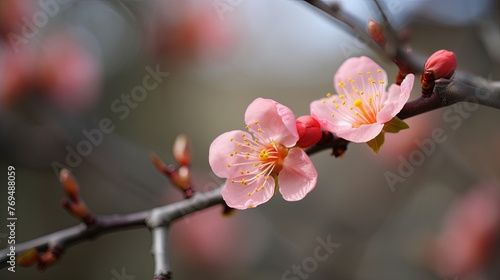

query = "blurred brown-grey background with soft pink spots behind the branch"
[0,0,500,280]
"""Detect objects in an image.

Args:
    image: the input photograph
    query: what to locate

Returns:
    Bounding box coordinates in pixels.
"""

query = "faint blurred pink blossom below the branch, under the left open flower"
[171,207,267,274]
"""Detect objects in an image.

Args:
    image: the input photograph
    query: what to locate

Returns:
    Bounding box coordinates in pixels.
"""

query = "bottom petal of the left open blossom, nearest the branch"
[221,176,275,210]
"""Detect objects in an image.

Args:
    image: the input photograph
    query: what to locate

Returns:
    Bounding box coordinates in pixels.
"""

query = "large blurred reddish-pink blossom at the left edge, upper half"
[0,33,101,113]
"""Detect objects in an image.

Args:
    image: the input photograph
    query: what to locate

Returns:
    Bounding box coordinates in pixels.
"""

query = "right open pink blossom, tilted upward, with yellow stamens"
[311,56,414,143]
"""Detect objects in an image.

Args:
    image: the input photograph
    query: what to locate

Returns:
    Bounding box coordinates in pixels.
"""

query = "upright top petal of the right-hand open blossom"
[333,56,387,91]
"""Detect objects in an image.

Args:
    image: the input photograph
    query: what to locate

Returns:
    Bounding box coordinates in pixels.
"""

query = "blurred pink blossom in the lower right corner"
[433,182,500,277]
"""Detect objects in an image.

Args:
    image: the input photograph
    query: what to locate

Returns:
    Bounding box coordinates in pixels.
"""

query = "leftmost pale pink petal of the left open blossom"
[208,130,251,178]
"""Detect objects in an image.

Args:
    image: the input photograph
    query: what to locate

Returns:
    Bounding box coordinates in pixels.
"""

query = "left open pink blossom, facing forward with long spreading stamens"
[209,98,318,209]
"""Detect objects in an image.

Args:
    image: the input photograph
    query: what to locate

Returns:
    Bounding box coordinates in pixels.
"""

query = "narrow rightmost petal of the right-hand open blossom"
[377,74,415,123]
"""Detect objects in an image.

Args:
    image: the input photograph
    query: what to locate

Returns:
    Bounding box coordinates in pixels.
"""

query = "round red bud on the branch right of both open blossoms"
[424,50,457,79]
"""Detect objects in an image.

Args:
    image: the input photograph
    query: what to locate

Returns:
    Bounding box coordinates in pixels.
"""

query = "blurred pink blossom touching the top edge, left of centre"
[147,0,235,62]
